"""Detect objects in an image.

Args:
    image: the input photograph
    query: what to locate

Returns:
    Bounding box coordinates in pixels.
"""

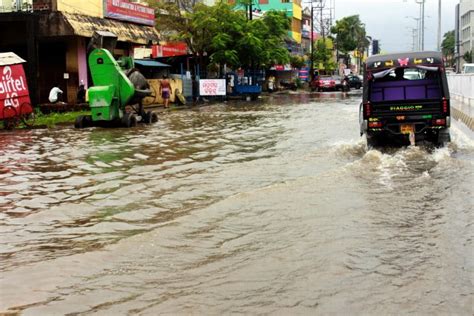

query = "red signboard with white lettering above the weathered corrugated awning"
[104,0,155,26]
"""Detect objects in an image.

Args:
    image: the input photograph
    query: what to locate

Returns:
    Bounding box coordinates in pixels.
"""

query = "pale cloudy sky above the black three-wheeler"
[334,0,459,53]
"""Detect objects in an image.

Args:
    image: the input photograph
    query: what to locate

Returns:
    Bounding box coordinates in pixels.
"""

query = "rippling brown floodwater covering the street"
[0,93,474,315]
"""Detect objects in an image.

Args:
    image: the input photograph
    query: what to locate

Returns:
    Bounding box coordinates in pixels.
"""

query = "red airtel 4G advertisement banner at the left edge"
[0,64,32,119]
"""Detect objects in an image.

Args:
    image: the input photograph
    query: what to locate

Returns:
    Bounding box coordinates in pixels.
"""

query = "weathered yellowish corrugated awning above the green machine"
[39,12,160,44]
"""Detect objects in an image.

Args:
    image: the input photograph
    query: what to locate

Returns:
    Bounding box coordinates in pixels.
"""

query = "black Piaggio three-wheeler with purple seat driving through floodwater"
[359,52,450,147]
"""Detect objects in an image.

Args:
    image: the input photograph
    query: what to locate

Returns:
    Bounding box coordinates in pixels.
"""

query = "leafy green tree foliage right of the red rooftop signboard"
[148,0,290,68]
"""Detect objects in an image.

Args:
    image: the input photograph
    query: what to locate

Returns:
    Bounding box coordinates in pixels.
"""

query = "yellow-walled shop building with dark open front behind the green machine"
[0,0,159,104]
